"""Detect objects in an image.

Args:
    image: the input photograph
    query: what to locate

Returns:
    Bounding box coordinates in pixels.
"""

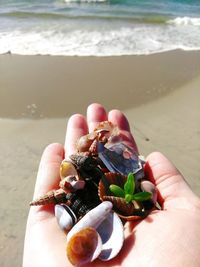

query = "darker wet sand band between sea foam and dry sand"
[0,51,200,118]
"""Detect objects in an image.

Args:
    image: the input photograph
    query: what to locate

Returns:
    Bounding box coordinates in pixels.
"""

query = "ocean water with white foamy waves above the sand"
[0,0,200,56]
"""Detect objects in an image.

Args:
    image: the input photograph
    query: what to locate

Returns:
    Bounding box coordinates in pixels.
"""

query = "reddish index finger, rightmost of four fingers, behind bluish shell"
[108,109,138,152]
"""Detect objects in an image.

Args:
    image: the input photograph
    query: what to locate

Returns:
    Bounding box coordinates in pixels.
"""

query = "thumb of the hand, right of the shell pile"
[145,152,200,210]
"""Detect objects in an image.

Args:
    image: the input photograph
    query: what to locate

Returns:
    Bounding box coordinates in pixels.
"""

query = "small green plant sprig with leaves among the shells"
[109,173,152,203]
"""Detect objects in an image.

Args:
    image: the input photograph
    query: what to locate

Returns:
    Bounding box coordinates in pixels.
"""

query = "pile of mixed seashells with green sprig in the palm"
[30,121,157,266]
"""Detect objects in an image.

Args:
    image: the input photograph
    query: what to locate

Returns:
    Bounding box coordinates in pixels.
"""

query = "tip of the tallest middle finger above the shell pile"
[87,103,108,132]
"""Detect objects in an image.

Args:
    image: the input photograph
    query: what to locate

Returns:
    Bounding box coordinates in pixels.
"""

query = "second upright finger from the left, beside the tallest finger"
[65,114,88,158]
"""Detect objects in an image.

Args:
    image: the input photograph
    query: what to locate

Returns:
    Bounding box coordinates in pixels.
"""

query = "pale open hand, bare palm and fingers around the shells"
[23,104,200,267]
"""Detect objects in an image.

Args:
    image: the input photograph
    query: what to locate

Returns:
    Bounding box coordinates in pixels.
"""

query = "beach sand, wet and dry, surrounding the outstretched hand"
[0,51,200,267]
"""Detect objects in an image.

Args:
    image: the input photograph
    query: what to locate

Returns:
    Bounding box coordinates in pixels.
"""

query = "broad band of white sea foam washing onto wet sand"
[0,21,200,56]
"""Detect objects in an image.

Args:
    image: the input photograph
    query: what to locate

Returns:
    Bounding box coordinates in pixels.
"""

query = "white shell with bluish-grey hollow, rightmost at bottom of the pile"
[97,212,124,261]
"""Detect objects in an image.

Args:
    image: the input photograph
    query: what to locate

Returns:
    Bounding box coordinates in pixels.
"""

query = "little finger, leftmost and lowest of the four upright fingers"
[34,143,64,198]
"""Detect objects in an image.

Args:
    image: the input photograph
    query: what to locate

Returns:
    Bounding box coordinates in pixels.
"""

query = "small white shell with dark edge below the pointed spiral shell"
[54,204,77,231]
